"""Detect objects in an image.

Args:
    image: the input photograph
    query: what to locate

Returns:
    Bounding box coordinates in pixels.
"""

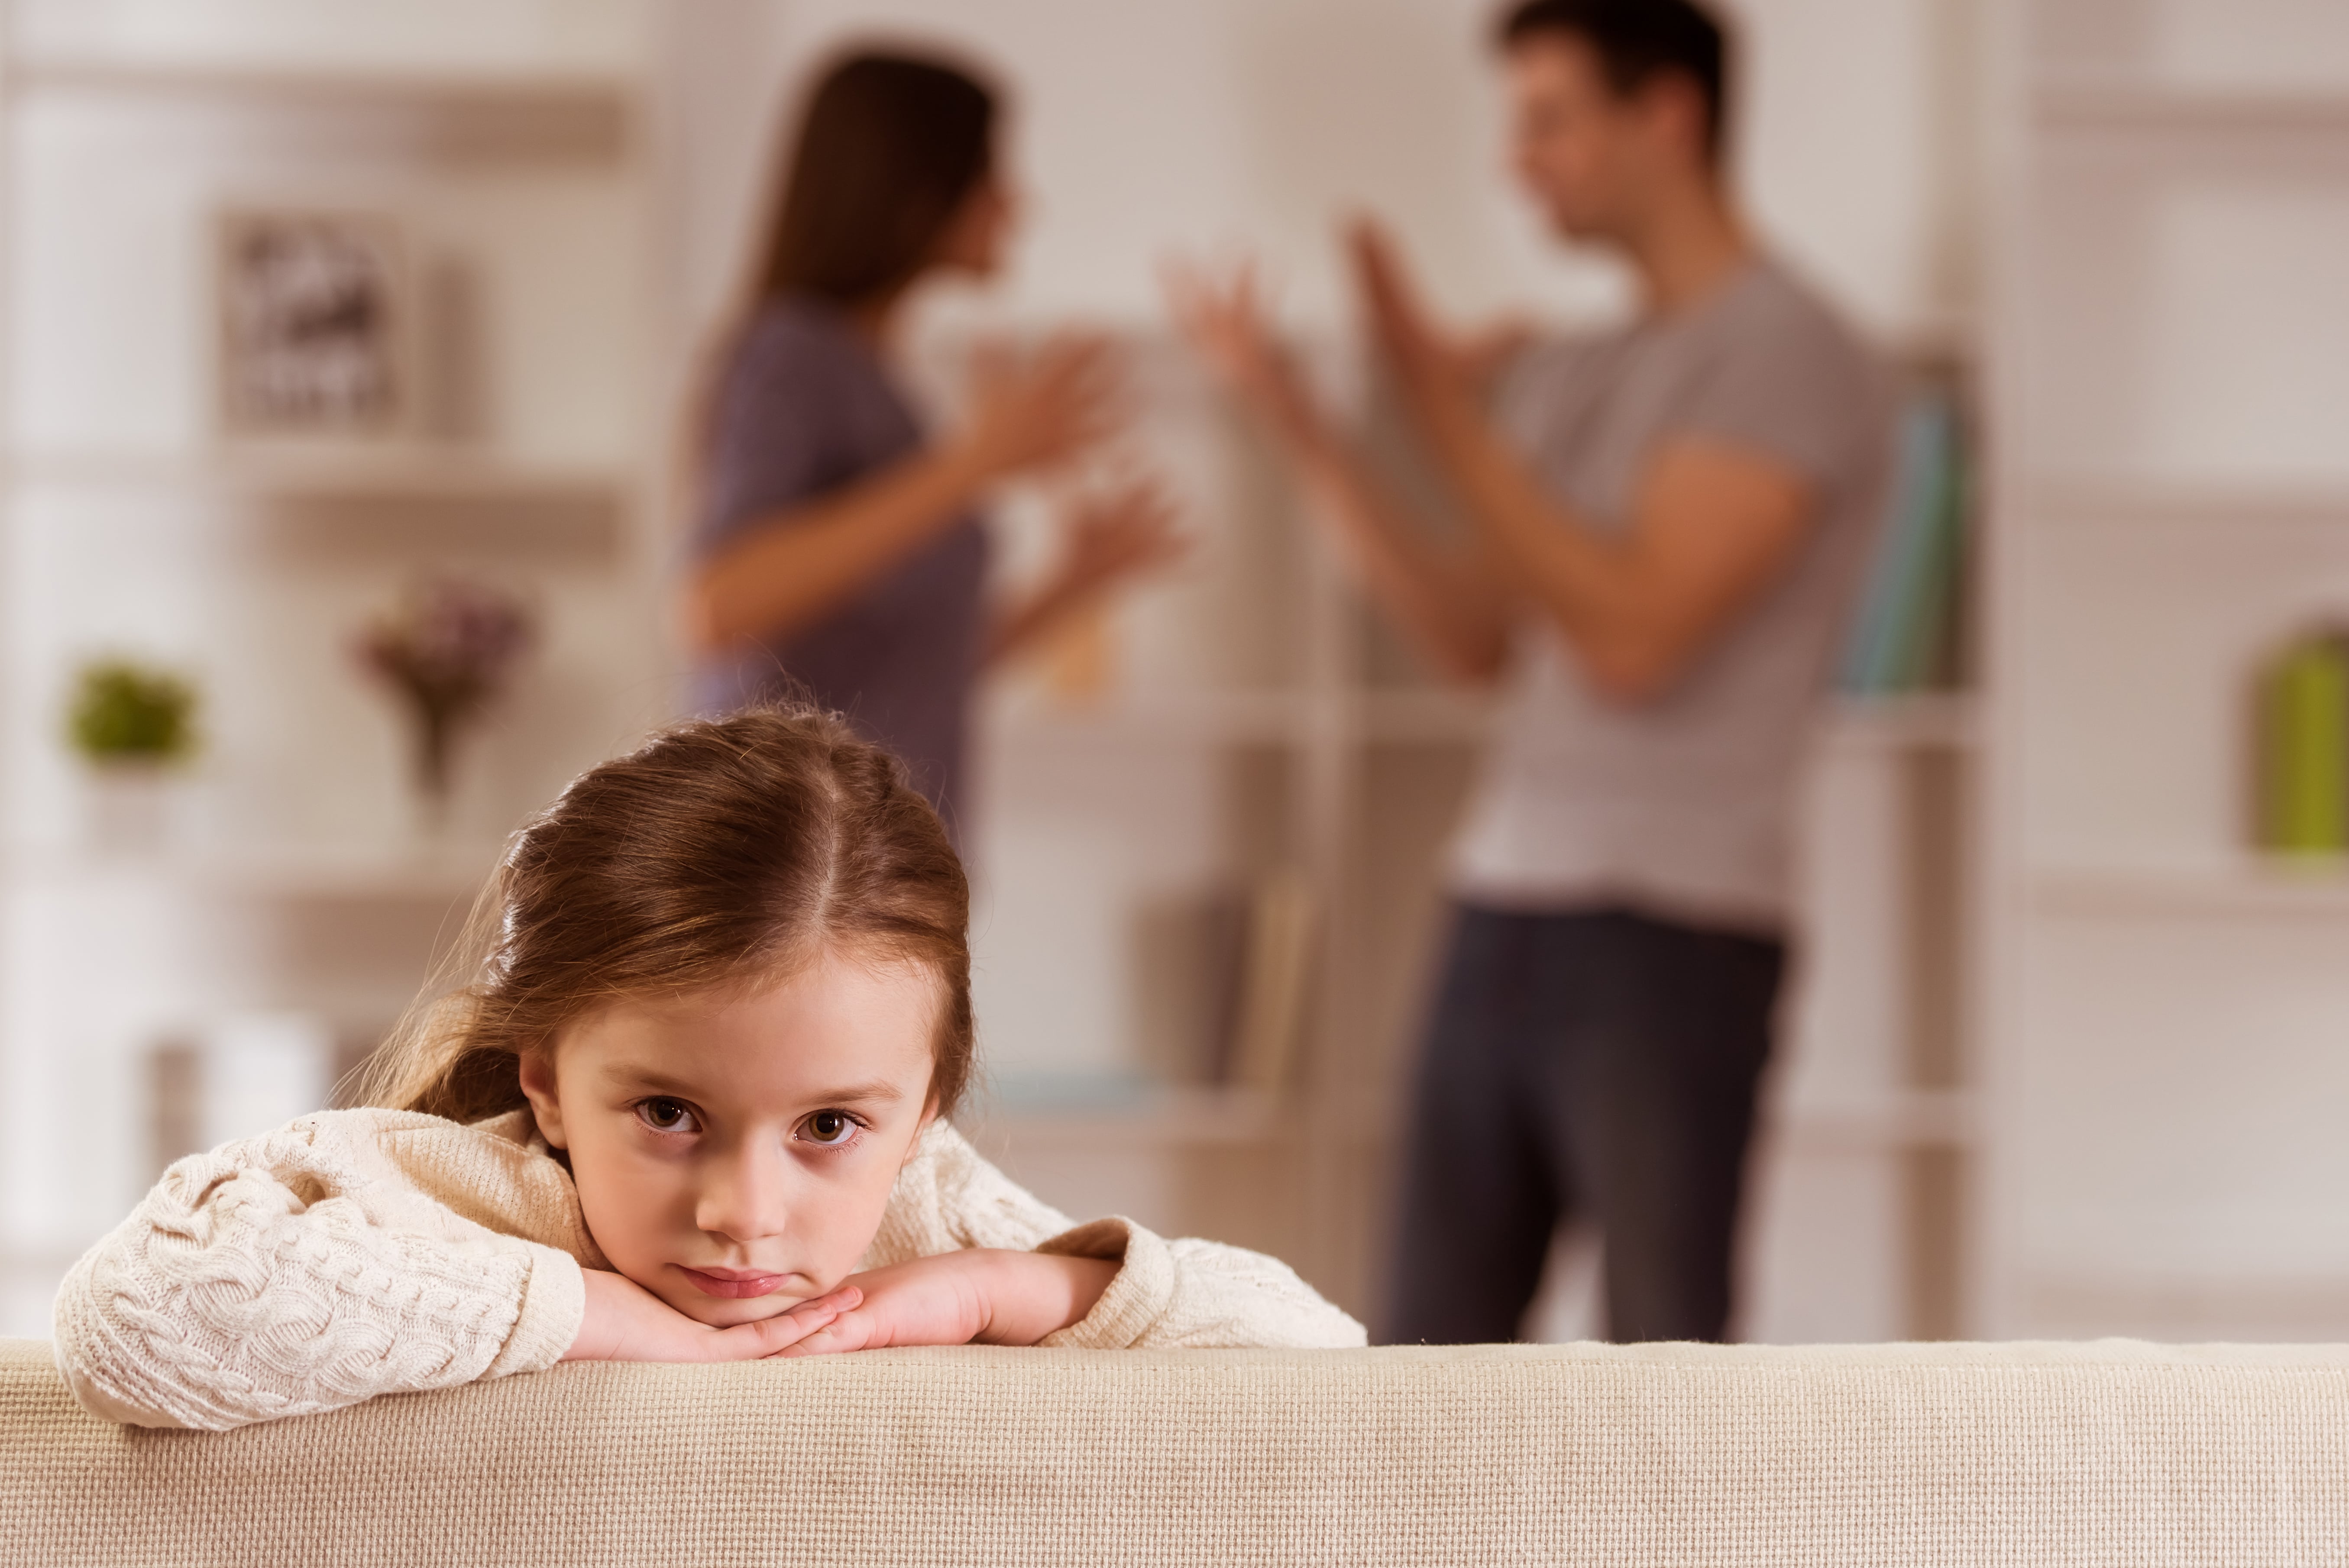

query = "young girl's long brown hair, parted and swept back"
[362,709,973,1122]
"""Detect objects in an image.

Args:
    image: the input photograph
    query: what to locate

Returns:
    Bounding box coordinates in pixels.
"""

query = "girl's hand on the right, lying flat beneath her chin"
[782,1249,1118,1357]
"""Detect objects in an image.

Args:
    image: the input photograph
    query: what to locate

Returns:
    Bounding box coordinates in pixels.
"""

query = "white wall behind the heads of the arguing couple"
[688,0,1968,336]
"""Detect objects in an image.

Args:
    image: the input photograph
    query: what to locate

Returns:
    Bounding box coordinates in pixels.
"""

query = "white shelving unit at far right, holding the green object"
[1971,0,2349,1340]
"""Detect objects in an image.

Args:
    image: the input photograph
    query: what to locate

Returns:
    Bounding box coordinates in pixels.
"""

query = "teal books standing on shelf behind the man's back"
[1837,394,1968,697]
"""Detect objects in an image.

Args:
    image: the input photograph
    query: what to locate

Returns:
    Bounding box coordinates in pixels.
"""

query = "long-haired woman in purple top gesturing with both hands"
[686,52,1177,826]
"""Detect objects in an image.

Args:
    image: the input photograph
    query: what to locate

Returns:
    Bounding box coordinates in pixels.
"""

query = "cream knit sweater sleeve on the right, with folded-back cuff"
[871,1122,1367,1350]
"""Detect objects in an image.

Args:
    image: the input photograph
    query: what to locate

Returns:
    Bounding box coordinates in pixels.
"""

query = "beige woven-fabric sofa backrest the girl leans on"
[0,1340,2349,1568]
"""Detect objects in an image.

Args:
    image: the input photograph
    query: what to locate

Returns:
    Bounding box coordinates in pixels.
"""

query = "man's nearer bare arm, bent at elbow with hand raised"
[1356,228,1818,702]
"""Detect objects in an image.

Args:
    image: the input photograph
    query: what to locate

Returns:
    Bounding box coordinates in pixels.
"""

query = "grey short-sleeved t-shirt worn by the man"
[1454,261,1891,930]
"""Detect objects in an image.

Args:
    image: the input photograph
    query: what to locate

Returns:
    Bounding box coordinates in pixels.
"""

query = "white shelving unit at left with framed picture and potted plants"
[0,0,674,1333]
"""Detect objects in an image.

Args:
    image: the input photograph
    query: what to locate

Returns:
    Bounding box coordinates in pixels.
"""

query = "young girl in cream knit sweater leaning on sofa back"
[56,711,1362,1429]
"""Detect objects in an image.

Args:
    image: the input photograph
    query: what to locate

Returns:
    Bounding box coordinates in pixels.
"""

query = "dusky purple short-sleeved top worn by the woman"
[693,298,987,828]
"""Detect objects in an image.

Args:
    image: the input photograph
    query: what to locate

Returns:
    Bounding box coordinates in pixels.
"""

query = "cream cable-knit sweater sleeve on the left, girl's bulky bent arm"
[54,1110,585,1429]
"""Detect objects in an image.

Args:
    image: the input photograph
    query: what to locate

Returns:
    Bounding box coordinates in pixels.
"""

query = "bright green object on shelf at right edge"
[2255,627,2349,854]
